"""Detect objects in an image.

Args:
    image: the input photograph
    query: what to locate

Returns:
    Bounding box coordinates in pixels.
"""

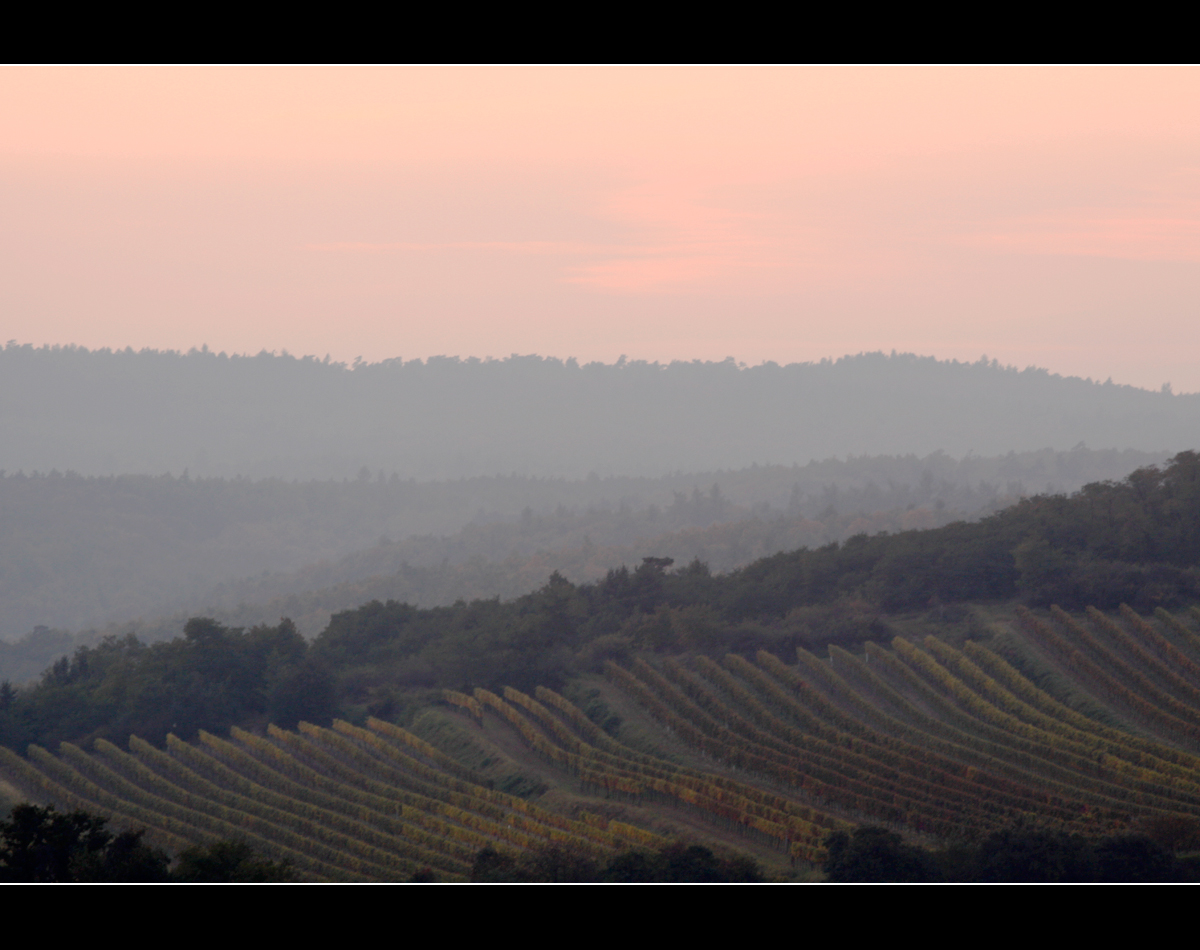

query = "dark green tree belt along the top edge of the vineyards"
[0,452,1200,747]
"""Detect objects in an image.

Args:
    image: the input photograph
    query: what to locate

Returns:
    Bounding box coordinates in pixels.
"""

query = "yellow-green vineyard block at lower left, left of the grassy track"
[0,720,666,880]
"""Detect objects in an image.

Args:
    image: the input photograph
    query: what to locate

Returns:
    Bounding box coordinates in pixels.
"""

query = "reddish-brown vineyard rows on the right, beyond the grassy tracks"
[590,608,1200,838]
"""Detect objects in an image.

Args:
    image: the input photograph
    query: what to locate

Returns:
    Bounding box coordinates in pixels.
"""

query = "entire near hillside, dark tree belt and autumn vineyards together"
[0,452,1200,879]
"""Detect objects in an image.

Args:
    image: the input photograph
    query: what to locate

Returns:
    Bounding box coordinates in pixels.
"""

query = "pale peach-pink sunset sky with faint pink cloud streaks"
[0,67,1200,392]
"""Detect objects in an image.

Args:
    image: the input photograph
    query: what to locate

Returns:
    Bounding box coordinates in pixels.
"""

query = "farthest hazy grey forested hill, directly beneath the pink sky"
[0,344,1200,480]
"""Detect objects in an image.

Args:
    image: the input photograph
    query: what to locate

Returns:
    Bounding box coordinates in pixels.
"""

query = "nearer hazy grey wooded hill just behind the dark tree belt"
[0,449,1163,647]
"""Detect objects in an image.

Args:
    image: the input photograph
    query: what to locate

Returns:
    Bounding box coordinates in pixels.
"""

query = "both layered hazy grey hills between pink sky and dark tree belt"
[0,347,1180,679]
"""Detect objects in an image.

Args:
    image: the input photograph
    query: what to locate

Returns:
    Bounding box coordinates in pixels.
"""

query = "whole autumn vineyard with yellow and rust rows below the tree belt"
[7,607,1200,880]
